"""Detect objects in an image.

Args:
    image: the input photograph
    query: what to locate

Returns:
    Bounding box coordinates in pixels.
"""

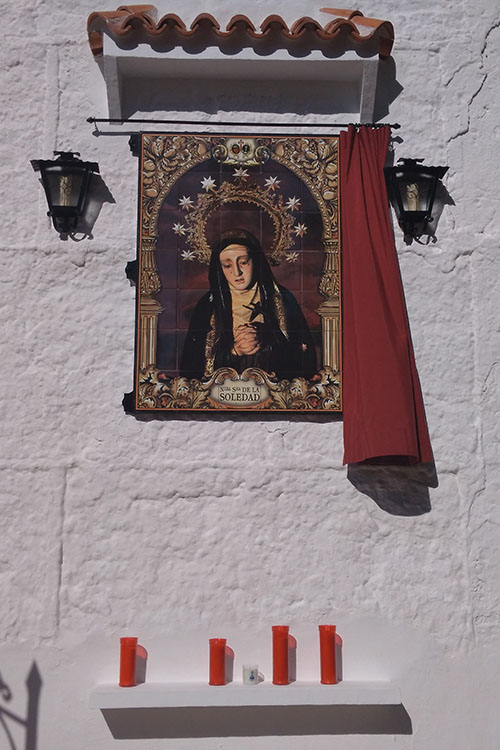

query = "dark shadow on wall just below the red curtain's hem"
[347,463,438,516]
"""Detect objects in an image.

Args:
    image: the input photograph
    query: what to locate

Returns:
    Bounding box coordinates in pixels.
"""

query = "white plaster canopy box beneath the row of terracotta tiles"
[97,26,380,122]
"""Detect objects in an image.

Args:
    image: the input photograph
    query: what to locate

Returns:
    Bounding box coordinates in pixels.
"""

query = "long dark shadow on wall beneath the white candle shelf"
[102,704,412,739]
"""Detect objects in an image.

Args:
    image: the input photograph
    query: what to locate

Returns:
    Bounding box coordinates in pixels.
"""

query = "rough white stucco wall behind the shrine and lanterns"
[0,0,500,750]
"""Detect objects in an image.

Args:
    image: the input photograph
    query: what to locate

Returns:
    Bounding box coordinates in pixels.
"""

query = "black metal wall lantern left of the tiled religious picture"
[31,151,99,234]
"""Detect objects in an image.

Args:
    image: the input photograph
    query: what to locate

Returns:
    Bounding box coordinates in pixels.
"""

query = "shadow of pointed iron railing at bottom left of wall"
[0,662,42,750]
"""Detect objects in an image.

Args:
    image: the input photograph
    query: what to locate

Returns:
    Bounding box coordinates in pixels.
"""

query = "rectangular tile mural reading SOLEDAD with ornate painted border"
[132,133,342,412]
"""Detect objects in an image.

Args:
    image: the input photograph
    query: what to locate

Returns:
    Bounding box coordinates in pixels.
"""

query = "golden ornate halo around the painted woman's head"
[185,181,294,265]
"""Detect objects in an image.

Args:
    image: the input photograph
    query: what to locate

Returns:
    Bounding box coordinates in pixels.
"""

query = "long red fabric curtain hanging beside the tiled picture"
[340,126,433,463]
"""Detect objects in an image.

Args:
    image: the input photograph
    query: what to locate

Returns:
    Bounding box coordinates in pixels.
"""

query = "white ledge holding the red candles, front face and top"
[89,682,401,709]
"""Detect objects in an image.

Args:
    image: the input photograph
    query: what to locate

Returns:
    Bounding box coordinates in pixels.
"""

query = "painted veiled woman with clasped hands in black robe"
[180,229,316,380]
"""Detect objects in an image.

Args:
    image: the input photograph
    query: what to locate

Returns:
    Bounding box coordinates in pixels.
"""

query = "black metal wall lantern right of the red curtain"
[384,159,448,245]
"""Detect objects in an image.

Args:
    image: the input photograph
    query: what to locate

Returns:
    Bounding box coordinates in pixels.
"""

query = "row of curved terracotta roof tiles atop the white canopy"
[87,5,394,57]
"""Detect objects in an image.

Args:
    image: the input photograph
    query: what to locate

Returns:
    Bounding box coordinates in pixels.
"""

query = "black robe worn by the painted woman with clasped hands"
[180,286,316,380]
